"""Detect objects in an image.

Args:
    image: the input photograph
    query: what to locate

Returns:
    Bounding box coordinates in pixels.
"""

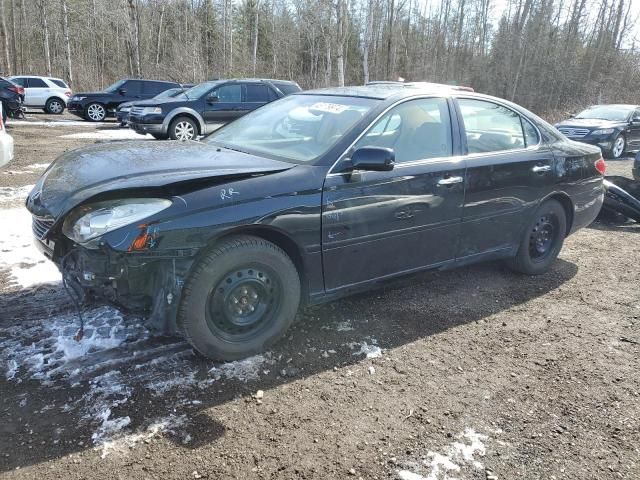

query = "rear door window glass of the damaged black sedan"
[458,98,537,153]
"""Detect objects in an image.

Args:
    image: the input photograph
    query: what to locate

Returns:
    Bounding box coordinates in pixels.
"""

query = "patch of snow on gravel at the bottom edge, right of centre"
[396,428,489,480]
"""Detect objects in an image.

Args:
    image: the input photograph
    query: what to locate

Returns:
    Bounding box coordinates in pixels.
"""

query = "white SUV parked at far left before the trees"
[9,76,71,115]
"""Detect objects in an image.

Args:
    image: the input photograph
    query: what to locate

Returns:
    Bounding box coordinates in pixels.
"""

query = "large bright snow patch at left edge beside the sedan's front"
[0,205,62,288]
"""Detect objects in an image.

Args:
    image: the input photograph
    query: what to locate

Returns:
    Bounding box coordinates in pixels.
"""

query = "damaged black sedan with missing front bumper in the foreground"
[27,86,605,360]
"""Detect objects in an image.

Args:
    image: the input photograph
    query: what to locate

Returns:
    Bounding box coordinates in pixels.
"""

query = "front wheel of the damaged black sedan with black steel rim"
[178,236,300,361]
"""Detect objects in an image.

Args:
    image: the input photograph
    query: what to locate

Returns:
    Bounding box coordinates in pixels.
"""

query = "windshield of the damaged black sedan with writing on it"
[207,95,379,163]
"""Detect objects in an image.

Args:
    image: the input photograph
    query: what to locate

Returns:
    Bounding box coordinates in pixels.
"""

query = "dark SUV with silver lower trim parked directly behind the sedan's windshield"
[129,79,300,140]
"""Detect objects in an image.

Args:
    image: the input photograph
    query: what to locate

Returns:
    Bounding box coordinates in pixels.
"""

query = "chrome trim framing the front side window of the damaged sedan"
[326,93,464,178]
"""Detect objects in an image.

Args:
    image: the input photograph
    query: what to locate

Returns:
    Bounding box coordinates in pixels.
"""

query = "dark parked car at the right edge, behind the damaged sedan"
[556,105,640,158]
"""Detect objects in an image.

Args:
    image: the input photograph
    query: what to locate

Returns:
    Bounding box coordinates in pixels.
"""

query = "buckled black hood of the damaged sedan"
[27,140,294,219]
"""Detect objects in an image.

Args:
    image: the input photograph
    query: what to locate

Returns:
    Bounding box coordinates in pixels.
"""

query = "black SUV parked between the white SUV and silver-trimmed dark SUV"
[68,79,181,122]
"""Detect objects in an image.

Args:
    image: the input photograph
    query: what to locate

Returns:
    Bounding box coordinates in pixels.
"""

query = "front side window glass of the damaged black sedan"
[355,98,453,163]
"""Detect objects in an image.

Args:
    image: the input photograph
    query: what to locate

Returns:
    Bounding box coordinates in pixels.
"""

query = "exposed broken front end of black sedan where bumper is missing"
[33,217,197,335]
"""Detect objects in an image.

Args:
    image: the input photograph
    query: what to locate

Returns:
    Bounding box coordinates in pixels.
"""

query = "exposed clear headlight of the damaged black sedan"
[62,198,171,245]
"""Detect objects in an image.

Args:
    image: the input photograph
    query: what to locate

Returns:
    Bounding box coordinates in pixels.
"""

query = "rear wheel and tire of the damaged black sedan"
[507,200,567,275]
